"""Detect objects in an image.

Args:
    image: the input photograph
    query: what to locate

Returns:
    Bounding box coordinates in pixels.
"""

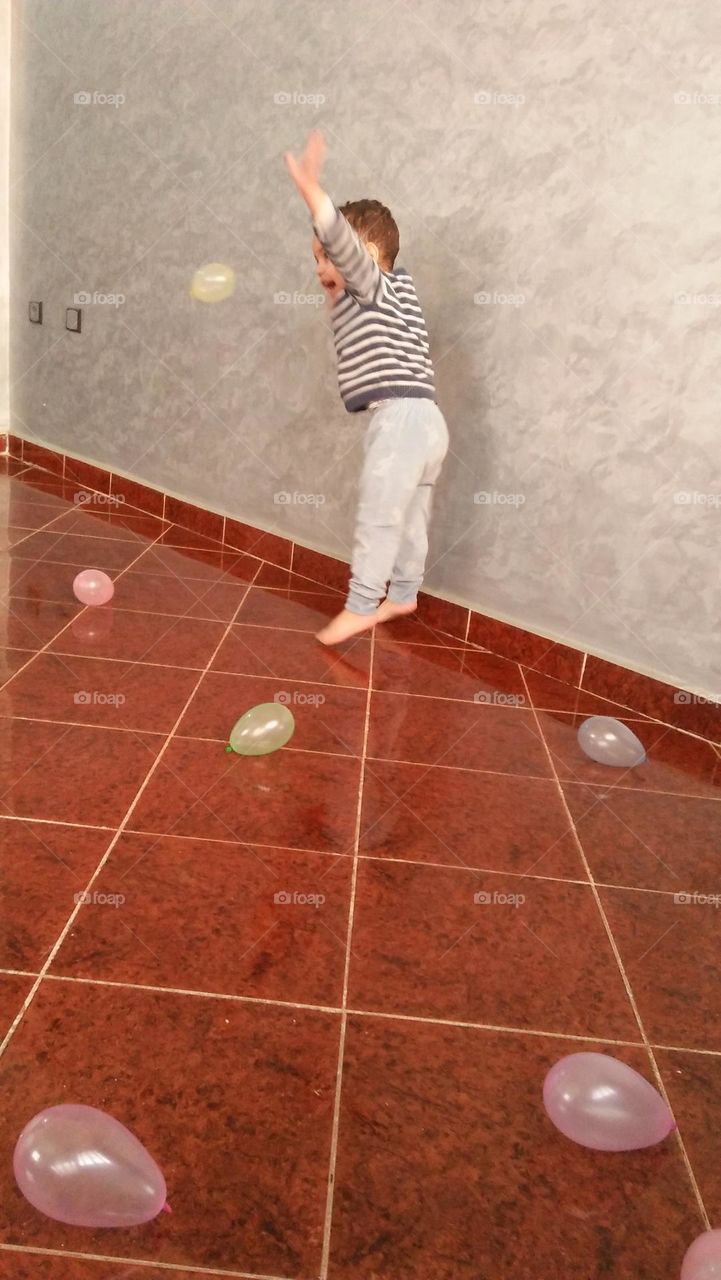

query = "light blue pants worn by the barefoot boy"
[346,397,448,613]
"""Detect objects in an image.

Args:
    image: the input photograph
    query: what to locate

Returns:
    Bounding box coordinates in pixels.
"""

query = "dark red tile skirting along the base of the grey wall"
[0,435,721,742]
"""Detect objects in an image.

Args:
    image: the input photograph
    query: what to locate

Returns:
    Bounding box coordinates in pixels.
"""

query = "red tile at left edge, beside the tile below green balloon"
[0,718,164,826]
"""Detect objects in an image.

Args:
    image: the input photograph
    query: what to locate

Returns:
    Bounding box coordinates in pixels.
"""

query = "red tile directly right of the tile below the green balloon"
[360,760,588,879]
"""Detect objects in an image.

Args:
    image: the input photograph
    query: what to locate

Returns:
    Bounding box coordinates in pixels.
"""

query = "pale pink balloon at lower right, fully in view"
[543,1053,676,1151]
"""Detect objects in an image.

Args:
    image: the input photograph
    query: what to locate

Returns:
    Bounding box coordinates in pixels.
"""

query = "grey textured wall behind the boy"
[12,0,721,694]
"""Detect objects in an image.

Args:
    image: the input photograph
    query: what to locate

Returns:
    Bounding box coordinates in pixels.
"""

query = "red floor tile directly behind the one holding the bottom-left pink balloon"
[51,835,352,1006]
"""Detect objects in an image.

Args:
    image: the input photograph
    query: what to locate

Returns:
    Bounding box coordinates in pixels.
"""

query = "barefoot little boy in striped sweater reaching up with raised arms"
[286,131,448,645]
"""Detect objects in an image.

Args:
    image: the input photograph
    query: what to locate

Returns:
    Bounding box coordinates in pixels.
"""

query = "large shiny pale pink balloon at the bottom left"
[13,1103,166,1226]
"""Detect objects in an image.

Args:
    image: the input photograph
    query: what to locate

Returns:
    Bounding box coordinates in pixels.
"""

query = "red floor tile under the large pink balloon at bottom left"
[0,980,338,1280]
